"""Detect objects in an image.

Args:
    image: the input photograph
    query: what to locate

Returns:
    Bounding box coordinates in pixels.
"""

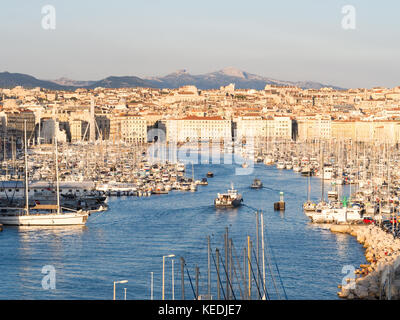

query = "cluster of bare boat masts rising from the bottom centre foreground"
[159,210,287,300]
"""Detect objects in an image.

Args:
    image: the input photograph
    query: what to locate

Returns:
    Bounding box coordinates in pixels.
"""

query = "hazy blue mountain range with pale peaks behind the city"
[0,67,344,90]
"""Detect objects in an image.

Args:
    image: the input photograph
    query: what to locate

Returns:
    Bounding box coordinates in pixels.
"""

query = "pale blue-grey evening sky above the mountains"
[0,0,400,88]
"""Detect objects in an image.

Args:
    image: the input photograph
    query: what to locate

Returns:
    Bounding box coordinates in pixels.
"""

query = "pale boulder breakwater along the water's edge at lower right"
[330,225,400,300]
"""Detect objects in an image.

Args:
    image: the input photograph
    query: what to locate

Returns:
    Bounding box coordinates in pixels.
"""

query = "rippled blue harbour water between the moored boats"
[0,160,365,299]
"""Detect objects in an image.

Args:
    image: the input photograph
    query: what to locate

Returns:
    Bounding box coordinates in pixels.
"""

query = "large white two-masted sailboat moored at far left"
[0,121,89,226]
